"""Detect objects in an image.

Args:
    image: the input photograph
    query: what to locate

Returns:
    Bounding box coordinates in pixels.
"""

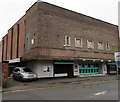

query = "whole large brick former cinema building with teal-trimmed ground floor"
[2,2,118,78]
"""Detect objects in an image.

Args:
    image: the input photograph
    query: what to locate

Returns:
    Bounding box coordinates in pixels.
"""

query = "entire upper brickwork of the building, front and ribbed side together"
[2,2,118,60]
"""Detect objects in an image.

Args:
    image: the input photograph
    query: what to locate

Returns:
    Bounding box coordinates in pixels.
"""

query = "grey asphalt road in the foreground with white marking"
[2,81,118,100]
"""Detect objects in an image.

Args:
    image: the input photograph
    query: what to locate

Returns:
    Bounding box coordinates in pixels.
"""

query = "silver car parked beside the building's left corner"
[13,67,37,81]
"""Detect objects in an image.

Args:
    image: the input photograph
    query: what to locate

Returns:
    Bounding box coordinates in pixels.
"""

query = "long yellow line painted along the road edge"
[0,80,117,93]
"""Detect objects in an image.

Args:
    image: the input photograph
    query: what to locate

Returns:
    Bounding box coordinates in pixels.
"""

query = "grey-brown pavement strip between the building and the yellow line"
[2,75,118,92]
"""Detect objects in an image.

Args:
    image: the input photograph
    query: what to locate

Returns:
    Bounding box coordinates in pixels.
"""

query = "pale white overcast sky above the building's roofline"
[0,0,120,40]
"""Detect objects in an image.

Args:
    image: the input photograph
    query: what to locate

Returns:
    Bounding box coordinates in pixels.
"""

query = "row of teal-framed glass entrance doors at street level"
[79,63,99,75]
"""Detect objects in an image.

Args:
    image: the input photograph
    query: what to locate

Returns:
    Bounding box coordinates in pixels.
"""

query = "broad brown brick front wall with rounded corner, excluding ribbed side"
[25,2,118,59]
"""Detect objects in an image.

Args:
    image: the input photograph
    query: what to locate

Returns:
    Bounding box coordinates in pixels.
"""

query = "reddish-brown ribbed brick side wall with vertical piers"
[3,16,25,61]
